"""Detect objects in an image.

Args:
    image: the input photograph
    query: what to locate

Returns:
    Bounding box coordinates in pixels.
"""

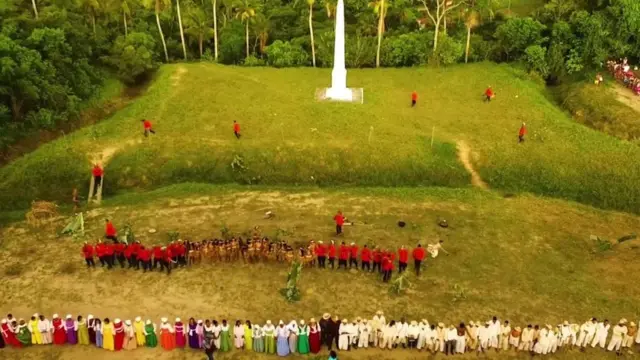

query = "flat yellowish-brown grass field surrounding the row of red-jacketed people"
[0,184,640,359]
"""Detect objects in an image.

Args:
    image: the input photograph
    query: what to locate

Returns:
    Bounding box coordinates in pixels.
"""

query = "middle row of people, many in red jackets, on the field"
[82,217,447,282]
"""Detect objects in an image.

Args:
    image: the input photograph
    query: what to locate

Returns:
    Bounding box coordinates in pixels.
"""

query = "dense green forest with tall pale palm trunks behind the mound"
[0,0,640,144]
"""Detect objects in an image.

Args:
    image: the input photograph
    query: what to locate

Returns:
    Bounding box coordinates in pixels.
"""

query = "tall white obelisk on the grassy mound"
[326,0,353,101]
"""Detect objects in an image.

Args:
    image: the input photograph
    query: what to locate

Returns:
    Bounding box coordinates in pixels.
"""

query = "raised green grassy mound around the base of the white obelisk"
[0,64,640,212]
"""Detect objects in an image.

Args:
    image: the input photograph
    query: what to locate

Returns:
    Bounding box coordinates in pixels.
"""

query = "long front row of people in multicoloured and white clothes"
[0,311,640,358]
